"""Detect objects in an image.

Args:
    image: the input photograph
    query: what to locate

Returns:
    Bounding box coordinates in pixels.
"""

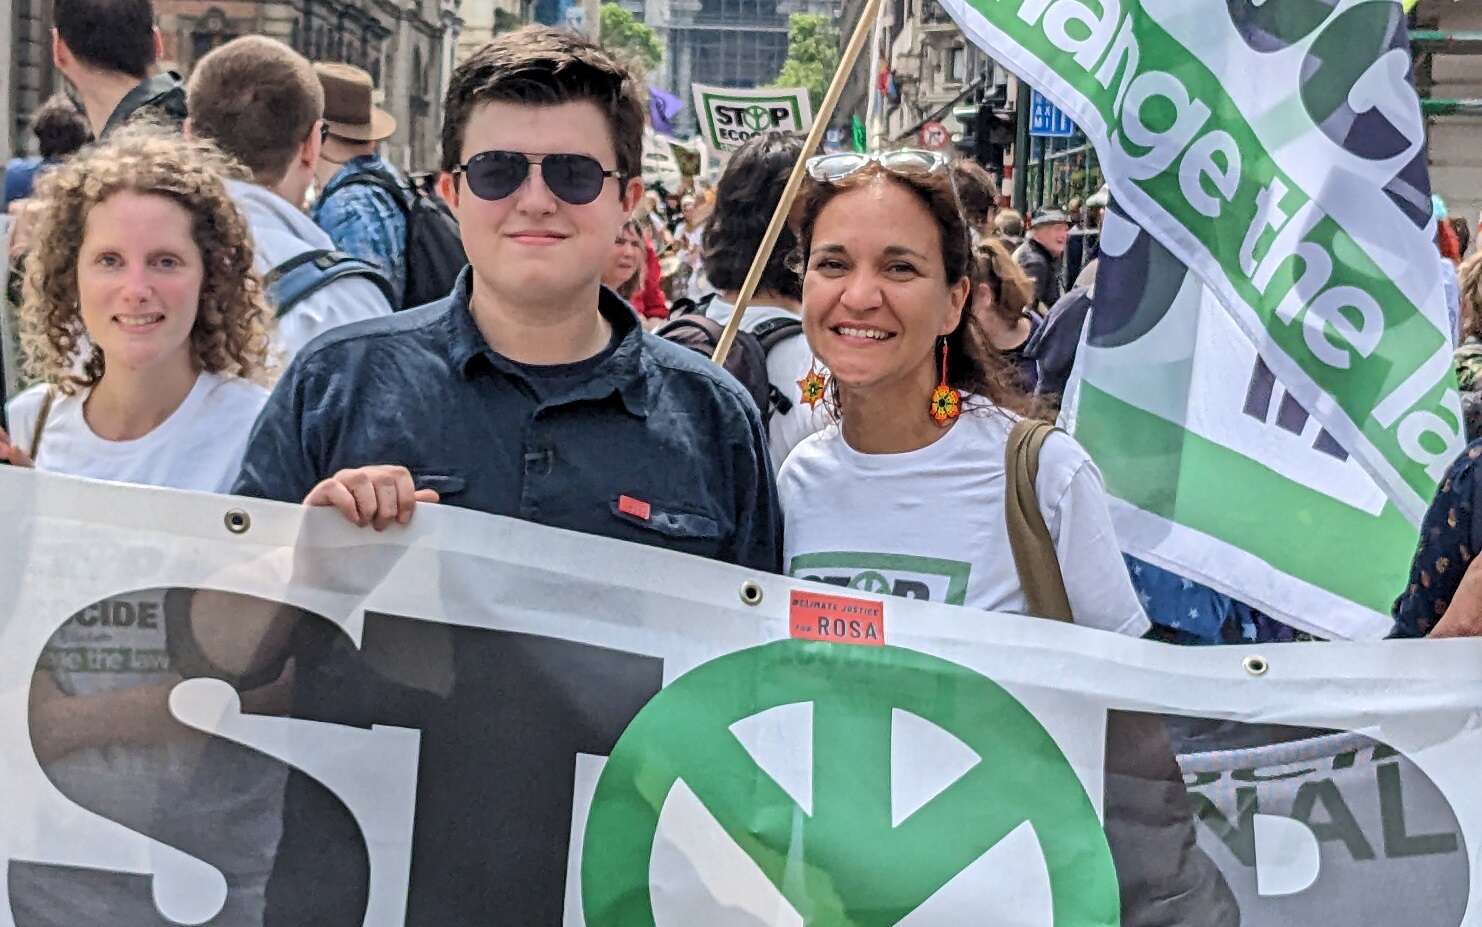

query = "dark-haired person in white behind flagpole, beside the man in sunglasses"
[701,130,828,468]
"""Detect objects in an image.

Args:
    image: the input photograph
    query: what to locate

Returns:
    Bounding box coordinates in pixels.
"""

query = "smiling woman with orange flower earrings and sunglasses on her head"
[778,151,1149,635]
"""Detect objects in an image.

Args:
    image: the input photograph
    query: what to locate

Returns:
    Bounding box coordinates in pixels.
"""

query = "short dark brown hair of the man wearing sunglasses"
[442,25,648,179]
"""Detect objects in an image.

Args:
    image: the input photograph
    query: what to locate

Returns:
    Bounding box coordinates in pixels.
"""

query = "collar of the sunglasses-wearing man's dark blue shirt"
[448,268,649,418]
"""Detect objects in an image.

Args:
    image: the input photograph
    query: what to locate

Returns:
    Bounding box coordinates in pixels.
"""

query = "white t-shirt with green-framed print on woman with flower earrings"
[778,398,1150,635]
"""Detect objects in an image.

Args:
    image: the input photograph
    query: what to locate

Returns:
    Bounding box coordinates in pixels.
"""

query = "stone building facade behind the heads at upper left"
[6,0,462,170]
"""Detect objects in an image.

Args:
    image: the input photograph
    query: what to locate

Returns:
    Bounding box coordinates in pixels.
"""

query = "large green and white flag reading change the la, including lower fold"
[944,0,1464,637]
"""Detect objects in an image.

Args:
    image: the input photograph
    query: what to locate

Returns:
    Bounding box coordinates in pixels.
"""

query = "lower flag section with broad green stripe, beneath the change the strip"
[1063,203,1415,640]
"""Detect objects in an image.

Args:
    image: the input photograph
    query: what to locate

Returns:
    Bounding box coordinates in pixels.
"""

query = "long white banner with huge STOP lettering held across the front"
[0,469,1482,927]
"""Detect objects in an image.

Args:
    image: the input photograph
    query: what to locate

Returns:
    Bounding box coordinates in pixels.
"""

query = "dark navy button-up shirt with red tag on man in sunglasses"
[234,271,782,572]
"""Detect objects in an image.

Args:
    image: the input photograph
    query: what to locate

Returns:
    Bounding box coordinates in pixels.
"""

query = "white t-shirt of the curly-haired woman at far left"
[7,373,268,493]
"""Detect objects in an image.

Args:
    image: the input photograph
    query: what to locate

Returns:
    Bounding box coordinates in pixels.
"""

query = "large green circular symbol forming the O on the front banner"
[581,640,1120,927]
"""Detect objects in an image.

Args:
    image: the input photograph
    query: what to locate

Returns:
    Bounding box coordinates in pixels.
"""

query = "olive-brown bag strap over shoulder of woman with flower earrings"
[1003,419,1073,622]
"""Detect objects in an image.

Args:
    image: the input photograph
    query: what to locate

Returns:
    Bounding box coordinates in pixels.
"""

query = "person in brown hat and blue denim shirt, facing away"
[310,62,406,308]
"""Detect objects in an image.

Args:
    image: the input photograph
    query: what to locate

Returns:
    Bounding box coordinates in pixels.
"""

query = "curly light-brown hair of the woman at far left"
[21,126,273,394]
